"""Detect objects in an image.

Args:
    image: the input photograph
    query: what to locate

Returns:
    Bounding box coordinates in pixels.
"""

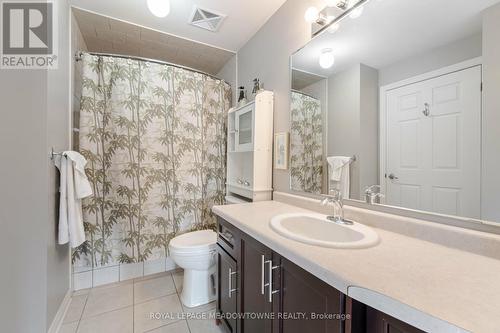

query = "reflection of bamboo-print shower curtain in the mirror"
[290,91,323,194]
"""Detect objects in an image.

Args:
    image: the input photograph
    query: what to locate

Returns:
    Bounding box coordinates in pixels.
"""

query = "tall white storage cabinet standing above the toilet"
[226,90,274,203]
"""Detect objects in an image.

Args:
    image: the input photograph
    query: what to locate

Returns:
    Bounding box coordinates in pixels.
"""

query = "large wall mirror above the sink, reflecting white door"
[290,0,500,222]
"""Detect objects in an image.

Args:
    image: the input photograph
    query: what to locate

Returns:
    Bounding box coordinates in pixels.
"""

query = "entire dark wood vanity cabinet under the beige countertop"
[217,218,422,333]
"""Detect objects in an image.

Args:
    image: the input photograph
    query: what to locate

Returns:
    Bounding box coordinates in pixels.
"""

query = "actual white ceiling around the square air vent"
[70,0,285,52]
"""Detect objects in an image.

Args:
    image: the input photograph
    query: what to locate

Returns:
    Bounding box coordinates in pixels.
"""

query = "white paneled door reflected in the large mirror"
[386,66,481,218]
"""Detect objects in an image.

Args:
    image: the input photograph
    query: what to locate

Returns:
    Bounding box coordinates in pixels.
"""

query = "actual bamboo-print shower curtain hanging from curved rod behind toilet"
[73,54,230,267]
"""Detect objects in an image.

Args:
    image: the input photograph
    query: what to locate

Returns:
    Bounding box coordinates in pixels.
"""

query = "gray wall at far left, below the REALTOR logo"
[0,57,49,332]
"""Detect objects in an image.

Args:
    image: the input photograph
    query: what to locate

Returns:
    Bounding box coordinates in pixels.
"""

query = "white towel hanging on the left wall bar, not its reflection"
[54,151,92,248]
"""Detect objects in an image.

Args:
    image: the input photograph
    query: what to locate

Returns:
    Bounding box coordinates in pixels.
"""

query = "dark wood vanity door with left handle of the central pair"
[241,236,272,333]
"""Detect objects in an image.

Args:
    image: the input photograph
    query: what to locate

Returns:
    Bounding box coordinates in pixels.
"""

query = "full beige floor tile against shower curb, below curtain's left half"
[82,283,134,318]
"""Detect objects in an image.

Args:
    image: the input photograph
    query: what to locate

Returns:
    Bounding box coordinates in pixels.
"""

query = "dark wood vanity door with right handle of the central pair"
[273,257,344,333]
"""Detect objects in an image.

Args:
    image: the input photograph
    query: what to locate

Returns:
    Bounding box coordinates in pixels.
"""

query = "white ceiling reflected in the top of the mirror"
[292,0,500,76]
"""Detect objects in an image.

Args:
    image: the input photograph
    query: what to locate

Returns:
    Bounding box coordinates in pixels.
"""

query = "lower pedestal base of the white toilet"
[180,265,217,308]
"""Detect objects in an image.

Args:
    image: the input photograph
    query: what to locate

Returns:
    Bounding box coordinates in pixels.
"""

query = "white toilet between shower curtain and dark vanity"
[169,230,217,308]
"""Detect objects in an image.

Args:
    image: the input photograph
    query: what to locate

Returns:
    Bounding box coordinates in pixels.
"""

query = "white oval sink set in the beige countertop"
[271,213,379,249]
